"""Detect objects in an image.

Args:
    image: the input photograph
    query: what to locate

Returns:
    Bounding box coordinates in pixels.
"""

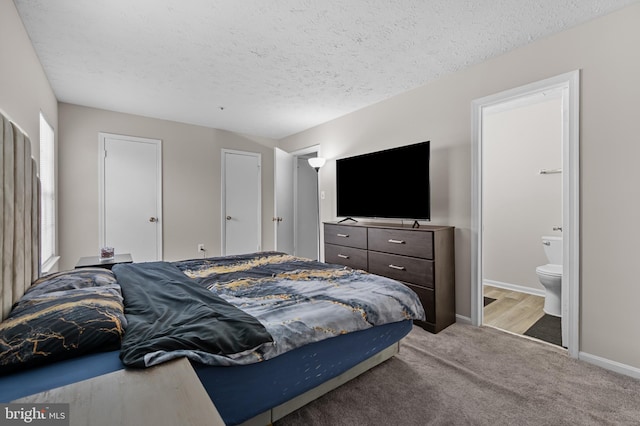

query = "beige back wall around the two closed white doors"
[59,103,275,269]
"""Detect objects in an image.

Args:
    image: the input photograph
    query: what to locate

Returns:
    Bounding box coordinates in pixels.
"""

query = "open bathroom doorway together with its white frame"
[472,71,579,357]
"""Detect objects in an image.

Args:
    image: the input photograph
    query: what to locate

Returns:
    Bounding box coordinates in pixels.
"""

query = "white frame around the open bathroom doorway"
[471,70,580,358]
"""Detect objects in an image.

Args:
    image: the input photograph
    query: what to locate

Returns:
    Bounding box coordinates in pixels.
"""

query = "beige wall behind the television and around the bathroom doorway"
[280,4,640,368]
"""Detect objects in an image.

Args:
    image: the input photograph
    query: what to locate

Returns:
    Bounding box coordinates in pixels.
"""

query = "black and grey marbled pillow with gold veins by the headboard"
[0,268,126,374]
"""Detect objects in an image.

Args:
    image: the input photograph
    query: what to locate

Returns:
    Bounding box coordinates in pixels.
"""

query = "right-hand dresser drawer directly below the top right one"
[369,251,434,288]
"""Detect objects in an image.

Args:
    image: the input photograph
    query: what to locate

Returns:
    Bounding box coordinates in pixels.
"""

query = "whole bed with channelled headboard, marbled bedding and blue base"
[0,110,424,425]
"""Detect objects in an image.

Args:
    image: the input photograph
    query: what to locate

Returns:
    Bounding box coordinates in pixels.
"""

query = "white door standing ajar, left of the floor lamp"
[273,148,295,254]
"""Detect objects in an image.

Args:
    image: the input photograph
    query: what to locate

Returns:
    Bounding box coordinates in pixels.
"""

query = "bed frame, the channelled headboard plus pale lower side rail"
[0,111,410,426]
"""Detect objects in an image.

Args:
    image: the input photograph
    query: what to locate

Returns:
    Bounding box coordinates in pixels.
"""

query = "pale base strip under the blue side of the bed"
[240,342,400,426]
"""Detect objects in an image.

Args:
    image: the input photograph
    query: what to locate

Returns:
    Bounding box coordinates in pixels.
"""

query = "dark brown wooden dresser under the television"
[324,222,456,333]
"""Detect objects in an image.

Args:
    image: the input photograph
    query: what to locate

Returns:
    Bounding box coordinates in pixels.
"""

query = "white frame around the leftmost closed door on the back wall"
[98,132,164,260]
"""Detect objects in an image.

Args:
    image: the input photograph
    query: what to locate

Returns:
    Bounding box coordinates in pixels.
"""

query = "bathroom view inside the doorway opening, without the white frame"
[482,95,562,346]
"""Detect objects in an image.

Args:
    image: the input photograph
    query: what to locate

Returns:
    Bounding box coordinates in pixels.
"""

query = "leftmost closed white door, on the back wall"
[99,133,162,262]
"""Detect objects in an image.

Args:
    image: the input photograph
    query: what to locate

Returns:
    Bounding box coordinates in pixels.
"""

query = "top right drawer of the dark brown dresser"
[369,228,433,259]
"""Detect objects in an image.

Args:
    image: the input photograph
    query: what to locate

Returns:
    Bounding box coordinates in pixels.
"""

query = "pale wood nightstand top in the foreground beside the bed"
[13,358,224,426]
